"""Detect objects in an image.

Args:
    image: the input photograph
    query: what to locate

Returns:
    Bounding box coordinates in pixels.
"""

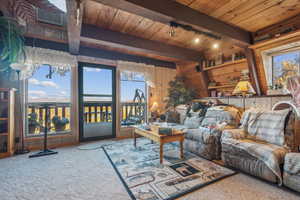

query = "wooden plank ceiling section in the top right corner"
[176,0,300,32]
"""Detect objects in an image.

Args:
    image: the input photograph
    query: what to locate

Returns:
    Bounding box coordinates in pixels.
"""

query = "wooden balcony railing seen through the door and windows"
[27,102,146,135]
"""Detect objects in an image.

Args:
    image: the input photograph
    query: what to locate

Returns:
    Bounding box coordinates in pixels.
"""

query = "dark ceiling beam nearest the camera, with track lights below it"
[94,0,251,47]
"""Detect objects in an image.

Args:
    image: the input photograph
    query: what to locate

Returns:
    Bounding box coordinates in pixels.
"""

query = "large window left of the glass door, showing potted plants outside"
[26,65,71,136]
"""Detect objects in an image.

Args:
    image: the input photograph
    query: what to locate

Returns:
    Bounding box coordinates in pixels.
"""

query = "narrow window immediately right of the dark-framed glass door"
[121,72,147,126]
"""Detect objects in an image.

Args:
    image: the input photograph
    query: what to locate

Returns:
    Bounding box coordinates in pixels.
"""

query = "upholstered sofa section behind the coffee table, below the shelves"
[162,103,241,160]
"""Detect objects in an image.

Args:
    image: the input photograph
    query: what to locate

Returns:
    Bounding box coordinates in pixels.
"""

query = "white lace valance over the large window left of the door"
[23,47,77,78]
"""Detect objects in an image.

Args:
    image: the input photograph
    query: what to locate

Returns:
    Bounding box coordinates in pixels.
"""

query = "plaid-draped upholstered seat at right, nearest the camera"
[221,109,297,185]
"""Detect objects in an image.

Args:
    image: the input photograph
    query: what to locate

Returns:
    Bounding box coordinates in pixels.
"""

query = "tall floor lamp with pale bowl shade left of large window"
[10,63,29,154]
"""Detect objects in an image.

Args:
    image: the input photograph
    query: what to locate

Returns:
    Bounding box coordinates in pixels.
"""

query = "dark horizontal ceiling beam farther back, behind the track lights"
[81,24,203,62]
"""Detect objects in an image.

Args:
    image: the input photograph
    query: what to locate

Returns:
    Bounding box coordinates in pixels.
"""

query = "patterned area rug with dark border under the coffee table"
[103,138,235,200]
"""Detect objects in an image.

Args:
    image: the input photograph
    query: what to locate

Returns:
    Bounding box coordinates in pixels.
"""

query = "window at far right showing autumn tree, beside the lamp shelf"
[272,51,300,88]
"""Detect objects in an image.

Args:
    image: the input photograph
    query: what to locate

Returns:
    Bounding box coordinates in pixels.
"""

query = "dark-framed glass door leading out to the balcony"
[79,63,116,141]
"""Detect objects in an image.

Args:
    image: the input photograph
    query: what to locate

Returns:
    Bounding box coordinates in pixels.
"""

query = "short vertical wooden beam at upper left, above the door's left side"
[66,0,84,55]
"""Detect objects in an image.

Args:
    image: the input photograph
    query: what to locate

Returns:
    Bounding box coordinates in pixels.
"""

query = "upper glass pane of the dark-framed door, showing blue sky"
[83,67,112,95]
